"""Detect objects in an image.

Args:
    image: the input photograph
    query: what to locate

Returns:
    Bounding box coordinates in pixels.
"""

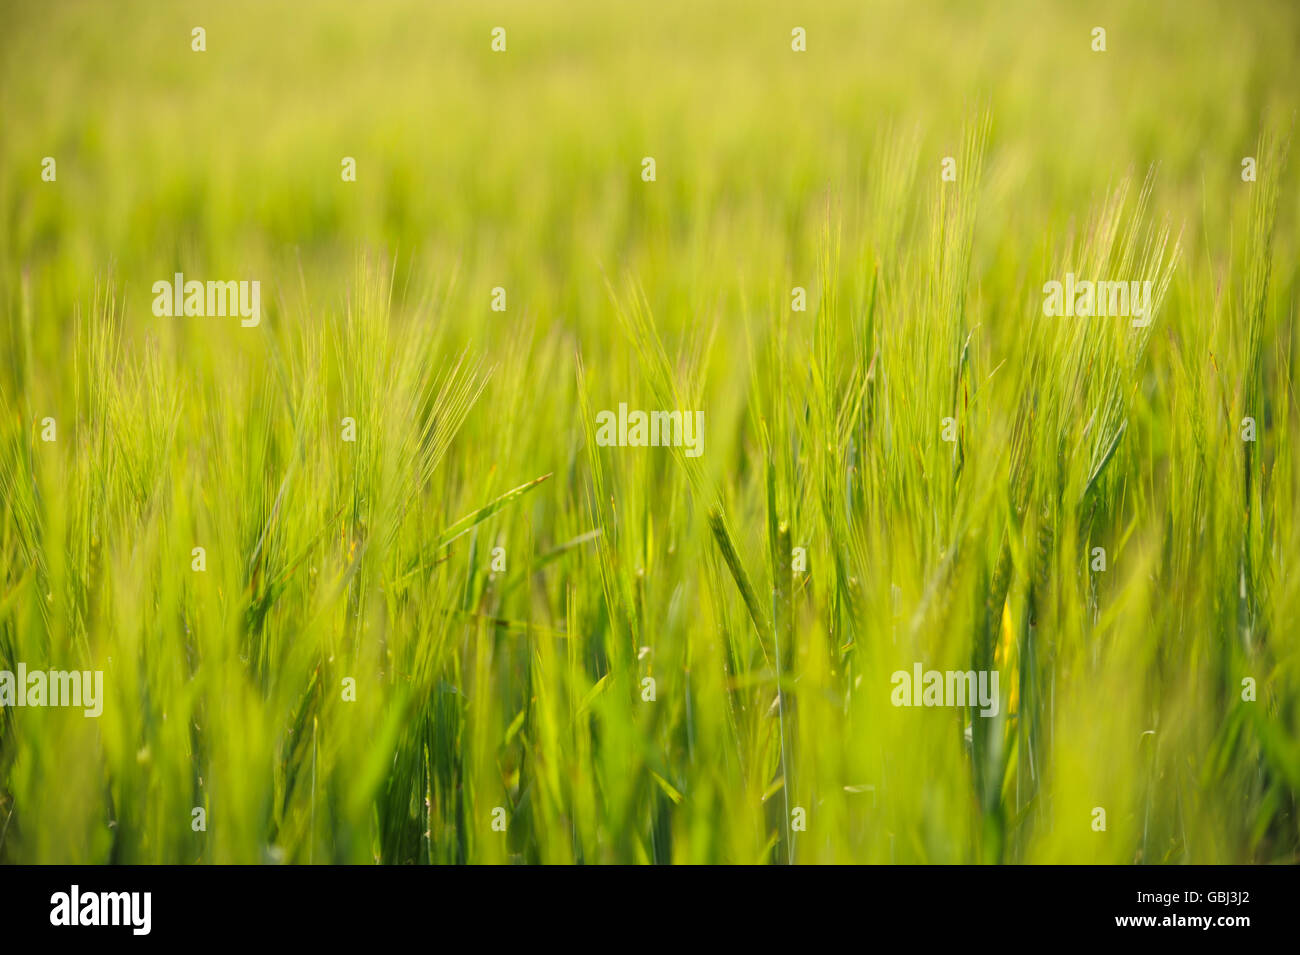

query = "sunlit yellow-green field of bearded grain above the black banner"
[0,0,1300,864]
